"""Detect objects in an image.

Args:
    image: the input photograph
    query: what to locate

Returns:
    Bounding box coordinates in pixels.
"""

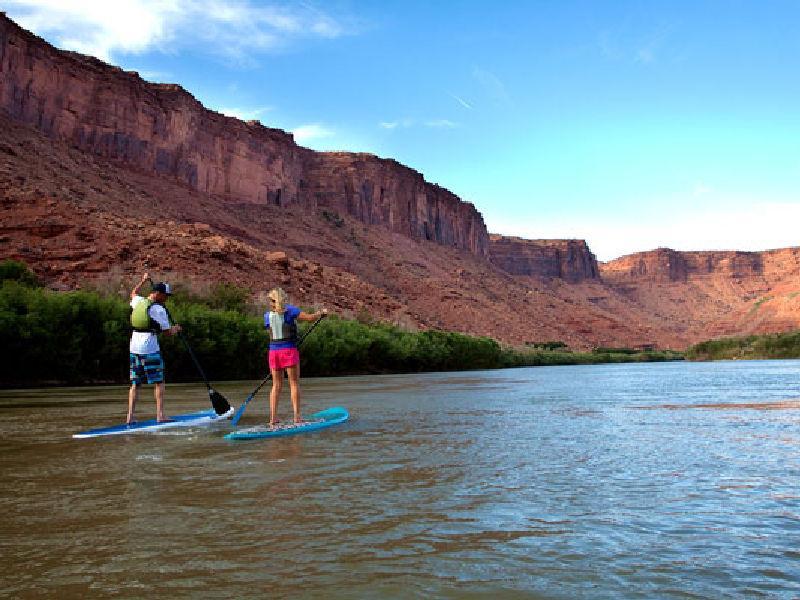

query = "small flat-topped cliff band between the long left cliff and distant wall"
[489,234,600,283]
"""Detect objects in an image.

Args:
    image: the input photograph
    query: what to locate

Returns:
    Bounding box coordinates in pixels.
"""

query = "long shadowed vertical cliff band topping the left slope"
[0,13,488,256]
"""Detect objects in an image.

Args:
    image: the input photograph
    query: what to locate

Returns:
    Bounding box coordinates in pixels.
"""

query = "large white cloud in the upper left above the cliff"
[3,0,355,63]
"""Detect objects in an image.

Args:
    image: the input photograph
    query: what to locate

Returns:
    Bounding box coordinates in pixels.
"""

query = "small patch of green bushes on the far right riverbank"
[686,331,800,360]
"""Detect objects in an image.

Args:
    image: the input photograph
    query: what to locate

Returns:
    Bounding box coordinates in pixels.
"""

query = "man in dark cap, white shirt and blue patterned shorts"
[126,273,181,425]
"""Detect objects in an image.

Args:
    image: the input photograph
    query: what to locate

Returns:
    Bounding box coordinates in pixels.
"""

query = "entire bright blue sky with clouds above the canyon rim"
[6,0,800,260]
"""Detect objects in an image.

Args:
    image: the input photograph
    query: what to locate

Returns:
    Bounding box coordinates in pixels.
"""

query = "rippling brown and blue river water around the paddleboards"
[0,361,800,598]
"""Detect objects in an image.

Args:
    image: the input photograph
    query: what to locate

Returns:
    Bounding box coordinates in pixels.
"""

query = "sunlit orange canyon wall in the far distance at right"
[600,248,800,343]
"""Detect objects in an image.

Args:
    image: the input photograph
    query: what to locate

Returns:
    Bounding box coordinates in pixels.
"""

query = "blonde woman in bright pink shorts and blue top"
[264,288,328,427]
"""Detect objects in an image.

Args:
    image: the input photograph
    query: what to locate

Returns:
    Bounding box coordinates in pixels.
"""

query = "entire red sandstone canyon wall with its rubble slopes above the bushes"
[0,10,800,348]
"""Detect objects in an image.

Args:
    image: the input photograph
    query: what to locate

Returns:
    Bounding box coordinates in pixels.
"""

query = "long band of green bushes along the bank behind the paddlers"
[0,261,682,386]
